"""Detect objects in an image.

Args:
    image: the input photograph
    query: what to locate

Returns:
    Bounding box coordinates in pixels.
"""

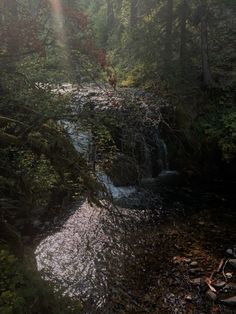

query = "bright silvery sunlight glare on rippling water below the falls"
[35,202,152,313]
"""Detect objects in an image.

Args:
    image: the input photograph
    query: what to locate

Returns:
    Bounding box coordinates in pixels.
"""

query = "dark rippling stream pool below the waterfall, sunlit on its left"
[35,84,236,314]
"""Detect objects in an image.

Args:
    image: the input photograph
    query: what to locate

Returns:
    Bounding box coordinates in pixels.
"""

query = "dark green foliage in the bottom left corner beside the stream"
[0,245,82,314]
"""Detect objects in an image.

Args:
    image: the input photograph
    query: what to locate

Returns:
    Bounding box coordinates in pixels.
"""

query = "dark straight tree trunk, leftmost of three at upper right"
[164,0,173,76]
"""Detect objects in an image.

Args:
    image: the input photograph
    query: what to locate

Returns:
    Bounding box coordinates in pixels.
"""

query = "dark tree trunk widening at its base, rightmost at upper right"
[201,0,213,88]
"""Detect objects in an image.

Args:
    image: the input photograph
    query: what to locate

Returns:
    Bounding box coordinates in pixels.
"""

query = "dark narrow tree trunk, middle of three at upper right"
[179,0,188,78]
